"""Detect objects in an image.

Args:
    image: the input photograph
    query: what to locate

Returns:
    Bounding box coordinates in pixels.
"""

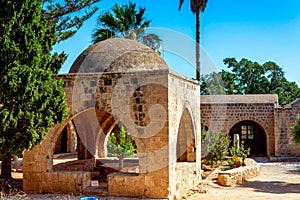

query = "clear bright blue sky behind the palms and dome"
[54,0,300,85]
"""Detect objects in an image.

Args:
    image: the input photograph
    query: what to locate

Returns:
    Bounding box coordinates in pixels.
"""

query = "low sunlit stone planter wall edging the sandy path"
[218,158,260,187]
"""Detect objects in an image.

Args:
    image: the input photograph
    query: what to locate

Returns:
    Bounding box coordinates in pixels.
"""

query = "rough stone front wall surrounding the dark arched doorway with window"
[201,95,278,155]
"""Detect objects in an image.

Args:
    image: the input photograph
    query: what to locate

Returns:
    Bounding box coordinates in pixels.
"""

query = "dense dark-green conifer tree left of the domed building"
[0,0,68,179]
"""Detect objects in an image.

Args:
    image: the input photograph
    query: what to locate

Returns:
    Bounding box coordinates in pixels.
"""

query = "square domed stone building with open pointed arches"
[23,39,201,199]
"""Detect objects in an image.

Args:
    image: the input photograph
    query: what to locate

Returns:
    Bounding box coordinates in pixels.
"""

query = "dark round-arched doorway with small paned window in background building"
[229,121,267,156]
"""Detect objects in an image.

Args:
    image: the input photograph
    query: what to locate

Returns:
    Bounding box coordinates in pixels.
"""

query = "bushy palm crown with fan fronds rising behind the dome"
[92,1,161,51]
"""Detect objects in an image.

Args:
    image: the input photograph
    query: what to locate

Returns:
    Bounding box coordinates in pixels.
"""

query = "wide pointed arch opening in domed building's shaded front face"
[52,108,139,184]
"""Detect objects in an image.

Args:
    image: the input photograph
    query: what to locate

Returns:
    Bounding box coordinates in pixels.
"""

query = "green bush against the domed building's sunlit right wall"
[201,131,230,167]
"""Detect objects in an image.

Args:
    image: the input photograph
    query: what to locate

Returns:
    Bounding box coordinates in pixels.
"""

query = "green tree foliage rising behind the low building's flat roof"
[201,58,300,103]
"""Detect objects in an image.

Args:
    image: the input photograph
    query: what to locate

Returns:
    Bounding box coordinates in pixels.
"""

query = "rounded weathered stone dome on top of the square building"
[69,38,168,73]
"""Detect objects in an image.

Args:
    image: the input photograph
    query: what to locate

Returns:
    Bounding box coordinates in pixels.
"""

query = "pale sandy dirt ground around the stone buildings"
[5,159,300,200]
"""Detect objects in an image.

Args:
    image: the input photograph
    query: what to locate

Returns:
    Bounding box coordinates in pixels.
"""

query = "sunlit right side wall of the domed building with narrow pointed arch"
[168,73,201,199]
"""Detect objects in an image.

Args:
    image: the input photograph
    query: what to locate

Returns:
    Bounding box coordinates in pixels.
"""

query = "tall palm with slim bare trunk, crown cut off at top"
[179,0,208,81]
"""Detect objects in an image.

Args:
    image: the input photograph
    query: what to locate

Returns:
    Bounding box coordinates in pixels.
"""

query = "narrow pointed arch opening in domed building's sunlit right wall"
[176,109,196,162]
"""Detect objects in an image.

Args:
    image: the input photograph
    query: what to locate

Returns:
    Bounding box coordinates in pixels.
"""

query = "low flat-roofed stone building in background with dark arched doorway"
[200,94,300,157]
